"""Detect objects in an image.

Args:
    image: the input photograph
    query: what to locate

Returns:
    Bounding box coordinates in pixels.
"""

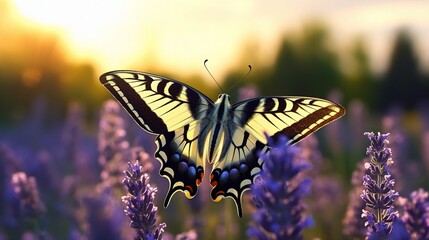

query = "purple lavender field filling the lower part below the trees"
[0,88,429,239]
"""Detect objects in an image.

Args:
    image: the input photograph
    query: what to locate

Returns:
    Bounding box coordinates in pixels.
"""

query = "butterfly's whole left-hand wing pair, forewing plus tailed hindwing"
[100,71,213,206]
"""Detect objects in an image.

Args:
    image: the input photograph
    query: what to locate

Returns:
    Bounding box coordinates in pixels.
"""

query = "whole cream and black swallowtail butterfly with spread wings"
[100,70,345,217]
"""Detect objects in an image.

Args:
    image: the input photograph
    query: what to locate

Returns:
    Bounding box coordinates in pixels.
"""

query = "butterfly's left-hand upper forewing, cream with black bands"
[100,70,213,134]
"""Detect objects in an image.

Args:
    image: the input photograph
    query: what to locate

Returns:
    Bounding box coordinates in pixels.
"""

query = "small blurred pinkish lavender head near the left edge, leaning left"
[12,172,45,218]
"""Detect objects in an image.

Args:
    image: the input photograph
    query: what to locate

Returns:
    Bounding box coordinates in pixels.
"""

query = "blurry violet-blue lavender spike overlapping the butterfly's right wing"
[247,137,312,239]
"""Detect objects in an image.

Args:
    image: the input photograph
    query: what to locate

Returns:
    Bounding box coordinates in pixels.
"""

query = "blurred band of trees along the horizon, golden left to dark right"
[0,22,429,124]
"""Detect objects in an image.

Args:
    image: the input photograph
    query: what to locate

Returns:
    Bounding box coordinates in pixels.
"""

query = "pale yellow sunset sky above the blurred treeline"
[7,0,429,78]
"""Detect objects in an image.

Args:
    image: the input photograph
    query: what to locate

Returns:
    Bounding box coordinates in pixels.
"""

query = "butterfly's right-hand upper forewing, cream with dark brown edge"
[231,97,345,144]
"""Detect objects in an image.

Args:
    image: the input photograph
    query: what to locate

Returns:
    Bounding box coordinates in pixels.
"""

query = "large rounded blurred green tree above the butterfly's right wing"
[258,23,342,97]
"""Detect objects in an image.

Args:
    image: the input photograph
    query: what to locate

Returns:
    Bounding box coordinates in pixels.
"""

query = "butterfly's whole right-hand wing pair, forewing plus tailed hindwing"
[210,97,345,216]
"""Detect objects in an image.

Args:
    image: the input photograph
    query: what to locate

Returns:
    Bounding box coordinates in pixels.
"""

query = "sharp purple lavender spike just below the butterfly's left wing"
[122,161,167,240]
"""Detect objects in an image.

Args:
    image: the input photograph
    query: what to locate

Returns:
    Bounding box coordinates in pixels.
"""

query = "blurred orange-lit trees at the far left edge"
[0,26,108,126]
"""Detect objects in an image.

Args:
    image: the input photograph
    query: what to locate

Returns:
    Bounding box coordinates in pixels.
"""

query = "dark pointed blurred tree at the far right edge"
[380,30,428,110]
